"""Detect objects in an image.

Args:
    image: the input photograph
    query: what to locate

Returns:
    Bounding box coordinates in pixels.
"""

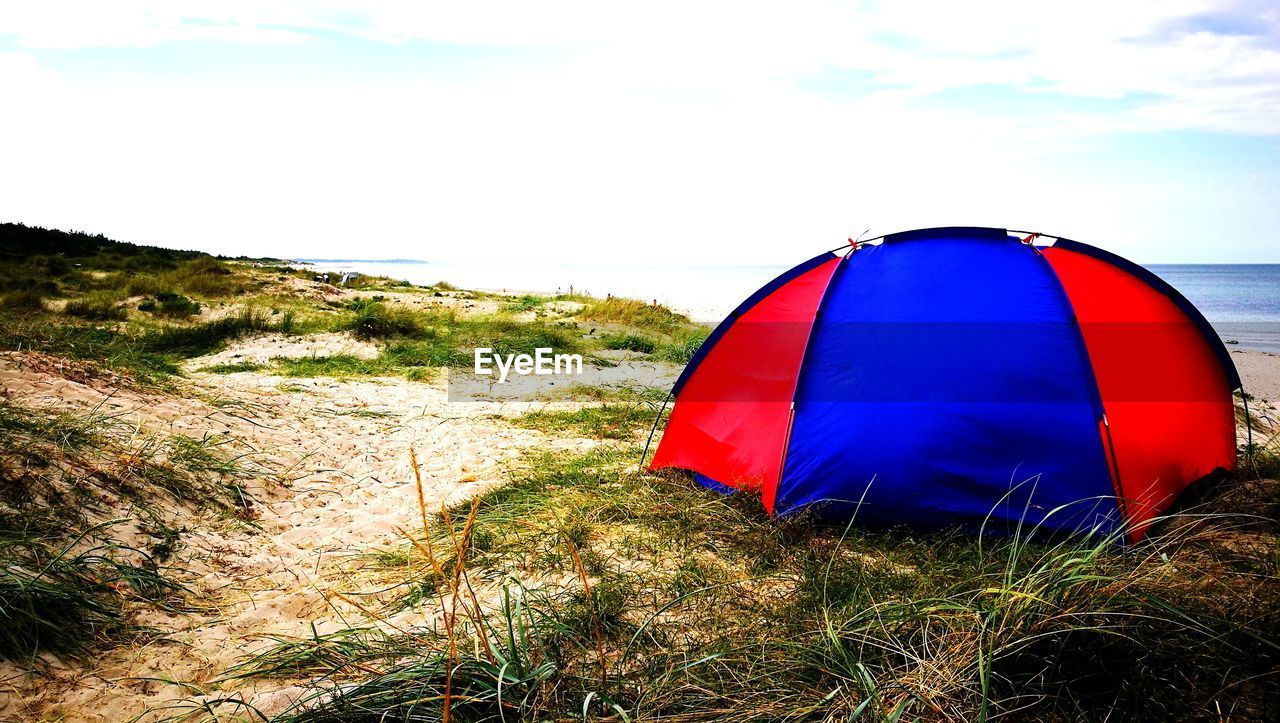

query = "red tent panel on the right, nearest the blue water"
[1044,247,1235,540]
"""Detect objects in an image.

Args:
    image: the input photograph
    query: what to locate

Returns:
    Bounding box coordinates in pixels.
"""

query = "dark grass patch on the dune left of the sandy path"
[0,401,264,664]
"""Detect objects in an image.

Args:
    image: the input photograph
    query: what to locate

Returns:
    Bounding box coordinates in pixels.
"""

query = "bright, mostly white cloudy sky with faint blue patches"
[0,0,1280,265]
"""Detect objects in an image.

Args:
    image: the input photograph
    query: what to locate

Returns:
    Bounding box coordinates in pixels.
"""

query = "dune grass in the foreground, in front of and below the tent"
[215,445,1280,720]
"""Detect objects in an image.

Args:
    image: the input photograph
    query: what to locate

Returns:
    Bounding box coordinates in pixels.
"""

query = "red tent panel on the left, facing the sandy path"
[650,257,840,512]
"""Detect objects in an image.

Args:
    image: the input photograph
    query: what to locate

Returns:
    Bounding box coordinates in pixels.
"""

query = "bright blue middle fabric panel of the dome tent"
[777,229,1119,530]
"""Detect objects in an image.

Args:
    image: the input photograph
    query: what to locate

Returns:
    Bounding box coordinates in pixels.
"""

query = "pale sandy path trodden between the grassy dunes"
[0,354,584,720]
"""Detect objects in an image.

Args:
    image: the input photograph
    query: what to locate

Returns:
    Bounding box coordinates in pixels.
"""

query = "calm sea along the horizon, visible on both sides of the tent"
[308,260,1280,353]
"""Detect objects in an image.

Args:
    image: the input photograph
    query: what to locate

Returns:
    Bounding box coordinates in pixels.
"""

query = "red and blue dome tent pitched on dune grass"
[650,228,1240,540]
